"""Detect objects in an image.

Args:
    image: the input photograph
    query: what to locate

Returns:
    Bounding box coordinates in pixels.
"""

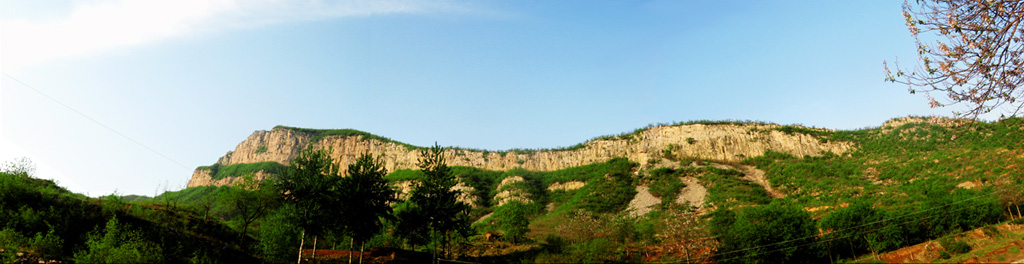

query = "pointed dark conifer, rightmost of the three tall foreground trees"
[397,143,469,261]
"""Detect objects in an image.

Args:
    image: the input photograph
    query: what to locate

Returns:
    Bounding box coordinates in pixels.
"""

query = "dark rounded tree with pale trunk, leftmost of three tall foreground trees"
[276,146,346,262]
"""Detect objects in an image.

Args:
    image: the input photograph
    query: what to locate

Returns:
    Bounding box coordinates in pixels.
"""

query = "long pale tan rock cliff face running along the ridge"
[188,124,854,186]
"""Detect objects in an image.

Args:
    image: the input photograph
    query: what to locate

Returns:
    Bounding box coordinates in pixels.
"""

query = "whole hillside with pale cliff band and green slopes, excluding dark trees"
[0,118,1024,263]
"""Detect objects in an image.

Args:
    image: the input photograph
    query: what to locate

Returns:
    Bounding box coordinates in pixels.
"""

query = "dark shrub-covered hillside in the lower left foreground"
[0,170,260,263]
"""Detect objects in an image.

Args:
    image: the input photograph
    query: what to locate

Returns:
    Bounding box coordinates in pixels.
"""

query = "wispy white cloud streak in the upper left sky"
[0,0,467,72]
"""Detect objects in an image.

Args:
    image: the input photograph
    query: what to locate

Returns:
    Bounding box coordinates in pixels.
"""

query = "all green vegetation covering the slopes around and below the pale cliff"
[8,119,1024,263]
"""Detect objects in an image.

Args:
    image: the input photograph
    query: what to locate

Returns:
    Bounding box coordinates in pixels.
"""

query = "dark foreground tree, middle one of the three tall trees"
[341,153,398,263]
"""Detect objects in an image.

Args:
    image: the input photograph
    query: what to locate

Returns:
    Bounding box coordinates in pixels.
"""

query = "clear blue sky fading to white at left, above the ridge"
[0,0,998,196]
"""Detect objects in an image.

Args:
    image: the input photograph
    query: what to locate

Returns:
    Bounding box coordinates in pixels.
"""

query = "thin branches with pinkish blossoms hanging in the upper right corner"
[885,0,1024,119]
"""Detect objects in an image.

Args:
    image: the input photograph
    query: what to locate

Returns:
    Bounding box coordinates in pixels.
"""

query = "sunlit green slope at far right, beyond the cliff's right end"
[746,120,1024,210]
